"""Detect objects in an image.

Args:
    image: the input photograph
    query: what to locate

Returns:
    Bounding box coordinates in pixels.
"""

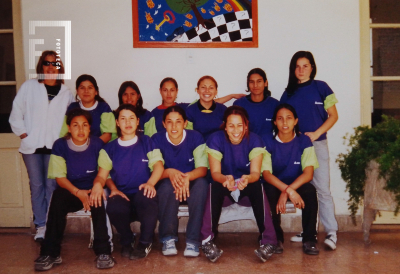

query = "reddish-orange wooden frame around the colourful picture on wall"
[132,0,258,48]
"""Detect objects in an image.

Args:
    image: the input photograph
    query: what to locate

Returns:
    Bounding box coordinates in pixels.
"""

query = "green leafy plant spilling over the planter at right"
[336,115,400,220]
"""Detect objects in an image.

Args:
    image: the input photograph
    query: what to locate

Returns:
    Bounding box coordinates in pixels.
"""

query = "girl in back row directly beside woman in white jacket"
[60,74,116,143]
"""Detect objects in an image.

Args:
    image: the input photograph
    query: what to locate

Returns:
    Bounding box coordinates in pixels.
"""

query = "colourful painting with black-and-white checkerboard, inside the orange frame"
[137,0,254,43]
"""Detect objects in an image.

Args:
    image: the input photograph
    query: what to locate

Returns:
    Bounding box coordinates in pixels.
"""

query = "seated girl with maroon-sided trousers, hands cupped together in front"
[201,106,277,262]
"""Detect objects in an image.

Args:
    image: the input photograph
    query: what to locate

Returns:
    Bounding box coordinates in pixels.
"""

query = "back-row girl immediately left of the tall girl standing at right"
[233,68,279,136]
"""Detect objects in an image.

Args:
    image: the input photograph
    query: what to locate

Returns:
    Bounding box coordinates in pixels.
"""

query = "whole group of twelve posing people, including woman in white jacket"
[10,51,338,270]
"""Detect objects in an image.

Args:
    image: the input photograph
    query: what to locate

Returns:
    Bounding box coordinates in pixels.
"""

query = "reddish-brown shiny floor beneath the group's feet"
[0,229,400,274]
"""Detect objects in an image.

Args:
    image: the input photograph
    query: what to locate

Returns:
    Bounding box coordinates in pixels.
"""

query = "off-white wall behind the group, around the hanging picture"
[22,0,360,214]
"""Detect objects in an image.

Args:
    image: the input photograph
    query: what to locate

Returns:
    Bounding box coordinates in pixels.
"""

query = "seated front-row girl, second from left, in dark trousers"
[90,104,164,259]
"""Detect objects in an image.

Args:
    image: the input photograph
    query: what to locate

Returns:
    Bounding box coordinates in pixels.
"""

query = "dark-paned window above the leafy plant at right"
[369,0,400,126]
